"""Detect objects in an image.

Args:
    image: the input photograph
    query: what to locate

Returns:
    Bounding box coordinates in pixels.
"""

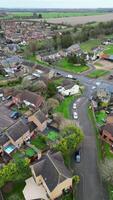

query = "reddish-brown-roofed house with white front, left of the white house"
[13,90,44,109]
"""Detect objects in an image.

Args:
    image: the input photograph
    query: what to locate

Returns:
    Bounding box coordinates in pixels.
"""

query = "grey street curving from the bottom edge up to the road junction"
[52,66,113,200]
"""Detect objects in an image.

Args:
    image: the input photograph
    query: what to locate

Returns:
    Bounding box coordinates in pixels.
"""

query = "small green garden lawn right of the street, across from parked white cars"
[95,110,107,126]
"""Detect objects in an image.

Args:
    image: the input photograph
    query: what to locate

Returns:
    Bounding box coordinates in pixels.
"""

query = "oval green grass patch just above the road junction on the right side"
[87,69,109,78]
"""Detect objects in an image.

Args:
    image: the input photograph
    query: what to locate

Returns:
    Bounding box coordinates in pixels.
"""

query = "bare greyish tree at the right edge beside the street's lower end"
[100,159,113,185]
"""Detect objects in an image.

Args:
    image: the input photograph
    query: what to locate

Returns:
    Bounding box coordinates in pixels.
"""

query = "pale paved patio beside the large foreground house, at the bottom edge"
[23,177,49,200]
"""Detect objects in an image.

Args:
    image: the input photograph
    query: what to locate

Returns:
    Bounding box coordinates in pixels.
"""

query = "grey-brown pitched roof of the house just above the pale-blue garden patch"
[7,120,29,141]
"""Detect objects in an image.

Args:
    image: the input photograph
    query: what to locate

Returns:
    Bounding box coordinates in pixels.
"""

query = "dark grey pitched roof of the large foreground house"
[32,152,72,191]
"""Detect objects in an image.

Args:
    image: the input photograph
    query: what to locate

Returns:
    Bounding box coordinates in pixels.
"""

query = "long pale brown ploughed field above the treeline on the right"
[48,14,113,26]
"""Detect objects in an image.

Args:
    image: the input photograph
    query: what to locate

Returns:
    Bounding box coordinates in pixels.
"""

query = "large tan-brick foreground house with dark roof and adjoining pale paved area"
[23,152,72,200]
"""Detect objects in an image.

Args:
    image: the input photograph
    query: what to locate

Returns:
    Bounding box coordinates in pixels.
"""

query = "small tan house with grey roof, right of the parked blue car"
[28,110,47,132]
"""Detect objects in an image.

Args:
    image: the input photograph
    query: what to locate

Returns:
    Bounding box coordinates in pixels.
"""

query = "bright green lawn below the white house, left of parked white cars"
[55,96,75,118]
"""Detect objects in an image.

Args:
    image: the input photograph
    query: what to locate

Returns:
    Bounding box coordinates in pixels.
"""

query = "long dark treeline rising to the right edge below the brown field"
[53,21,113,49]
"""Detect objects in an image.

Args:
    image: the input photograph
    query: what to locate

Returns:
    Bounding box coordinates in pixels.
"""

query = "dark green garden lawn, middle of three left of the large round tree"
[31,135,47,150]
